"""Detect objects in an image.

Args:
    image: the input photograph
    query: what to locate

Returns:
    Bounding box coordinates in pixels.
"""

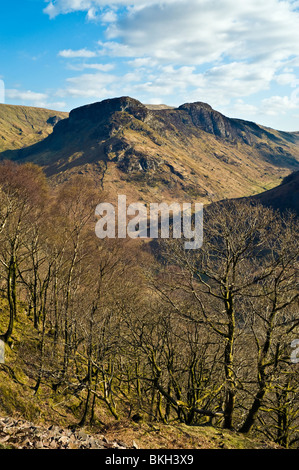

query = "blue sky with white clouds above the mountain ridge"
[0,0,299,131]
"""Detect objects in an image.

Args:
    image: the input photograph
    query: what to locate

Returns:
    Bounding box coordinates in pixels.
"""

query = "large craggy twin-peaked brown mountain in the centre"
[0,97,299,202]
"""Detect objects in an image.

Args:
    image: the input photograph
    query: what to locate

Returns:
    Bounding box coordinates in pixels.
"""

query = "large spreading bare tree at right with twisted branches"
[154,202,298,432]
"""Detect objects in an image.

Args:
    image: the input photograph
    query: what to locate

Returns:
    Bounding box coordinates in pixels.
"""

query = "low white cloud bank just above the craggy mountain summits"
[54,57,296,114]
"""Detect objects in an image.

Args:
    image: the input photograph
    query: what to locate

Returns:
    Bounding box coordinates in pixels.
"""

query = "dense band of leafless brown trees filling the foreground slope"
[0,162,299,448]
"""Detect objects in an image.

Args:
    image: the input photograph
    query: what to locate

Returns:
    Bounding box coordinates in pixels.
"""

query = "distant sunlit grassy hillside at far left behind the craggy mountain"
[0,104,68,152]
